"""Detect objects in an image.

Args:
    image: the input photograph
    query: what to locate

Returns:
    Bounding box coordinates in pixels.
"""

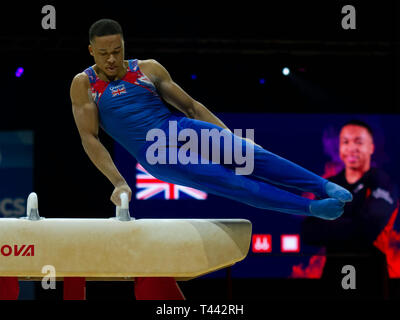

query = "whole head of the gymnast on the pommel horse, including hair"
[89,19,125,77]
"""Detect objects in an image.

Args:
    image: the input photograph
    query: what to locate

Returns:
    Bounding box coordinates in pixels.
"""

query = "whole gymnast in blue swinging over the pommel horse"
[70,19,352,220]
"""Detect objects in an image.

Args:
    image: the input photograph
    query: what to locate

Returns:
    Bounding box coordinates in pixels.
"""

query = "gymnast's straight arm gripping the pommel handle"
[70,73,132,205]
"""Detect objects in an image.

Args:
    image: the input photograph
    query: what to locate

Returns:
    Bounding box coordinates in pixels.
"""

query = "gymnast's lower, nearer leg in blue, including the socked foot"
[138,159,344,220]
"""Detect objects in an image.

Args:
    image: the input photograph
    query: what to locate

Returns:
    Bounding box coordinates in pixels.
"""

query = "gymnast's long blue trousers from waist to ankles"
[135,116,328,215]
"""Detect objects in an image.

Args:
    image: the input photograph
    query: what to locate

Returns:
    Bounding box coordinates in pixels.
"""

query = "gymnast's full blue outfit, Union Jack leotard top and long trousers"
[85,59,340,215]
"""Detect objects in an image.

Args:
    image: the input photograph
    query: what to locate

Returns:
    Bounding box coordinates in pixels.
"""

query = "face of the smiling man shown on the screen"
[339,125,374,172]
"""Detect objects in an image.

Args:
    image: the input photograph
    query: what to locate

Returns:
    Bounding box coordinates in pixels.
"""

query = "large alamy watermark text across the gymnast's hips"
[146,121,254,175]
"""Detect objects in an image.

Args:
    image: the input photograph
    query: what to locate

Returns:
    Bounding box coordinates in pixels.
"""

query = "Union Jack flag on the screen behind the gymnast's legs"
[136,163,207,200]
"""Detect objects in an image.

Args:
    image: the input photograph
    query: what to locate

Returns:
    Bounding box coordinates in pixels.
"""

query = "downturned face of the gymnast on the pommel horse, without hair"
[89,34,125,78]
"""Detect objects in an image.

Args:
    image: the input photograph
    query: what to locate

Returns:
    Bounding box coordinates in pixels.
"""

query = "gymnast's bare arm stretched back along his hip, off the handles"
[140,59,229,130]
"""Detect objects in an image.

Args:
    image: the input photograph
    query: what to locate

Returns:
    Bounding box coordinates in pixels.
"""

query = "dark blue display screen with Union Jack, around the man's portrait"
[114,113,400,278]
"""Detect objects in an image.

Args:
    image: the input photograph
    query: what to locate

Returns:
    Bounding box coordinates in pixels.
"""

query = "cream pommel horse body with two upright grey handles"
[0,192,252,299]
